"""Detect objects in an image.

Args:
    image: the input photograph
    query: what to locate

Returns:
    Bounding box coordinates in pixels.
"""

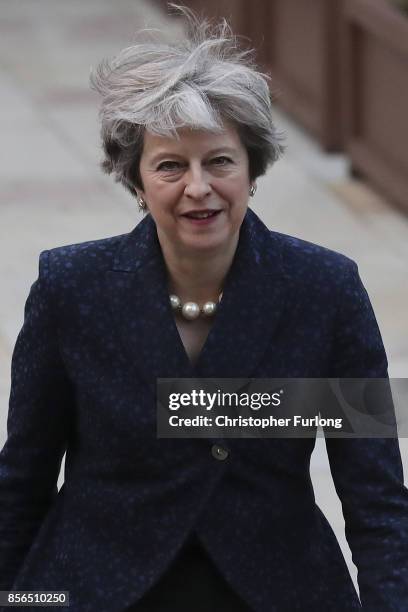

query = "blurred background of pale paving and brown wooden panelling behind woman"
[0,0,408,592]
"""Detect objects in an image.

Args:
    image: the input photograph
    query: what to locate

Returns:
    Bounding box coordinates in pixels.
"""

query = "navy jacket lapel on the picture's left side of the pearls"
[107,215,193,388]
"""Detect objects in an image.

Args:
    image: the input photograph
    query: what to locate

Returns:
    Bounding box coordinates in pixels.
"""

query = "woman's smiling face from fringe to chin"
[138,124,250,254]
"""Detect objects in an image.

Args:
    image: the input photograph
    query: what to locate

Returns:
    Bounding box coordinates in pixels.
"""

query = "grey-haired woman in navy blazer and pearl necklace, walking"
[0,5,408,612]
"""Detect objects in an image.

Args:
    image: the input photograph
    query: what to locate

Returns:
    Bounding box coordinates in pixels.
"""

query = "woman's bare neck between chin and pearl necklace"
[159,234,239,303]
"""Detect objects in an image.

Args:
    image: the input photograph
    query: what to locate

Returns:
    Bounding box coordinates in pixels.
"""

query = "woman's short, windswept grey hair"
[90,5,283,195]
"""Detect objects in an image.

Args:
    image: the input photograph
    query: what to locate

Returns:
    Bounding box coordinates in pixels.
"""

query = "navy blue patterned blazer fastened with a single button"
[0,210,408,612]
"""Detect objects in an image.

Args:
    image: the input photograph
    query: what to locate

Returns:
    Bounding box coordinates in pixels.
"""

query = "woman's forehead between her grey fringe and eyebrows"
[143,124,244,159]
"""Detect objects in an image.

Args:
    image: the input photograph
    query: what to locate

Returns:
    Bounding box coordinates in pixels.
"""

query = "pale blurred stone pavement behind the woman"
[0,0,408,592]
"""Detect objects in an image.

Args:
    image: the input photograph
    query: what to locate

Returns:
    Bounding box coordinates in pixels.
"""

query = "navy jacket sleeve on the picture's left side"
[0,251,72,590]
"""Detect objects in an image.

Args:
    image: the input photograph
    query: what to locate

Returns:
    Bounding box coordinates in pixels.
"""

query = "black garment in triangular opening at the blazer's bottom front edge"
[127,534,251,612]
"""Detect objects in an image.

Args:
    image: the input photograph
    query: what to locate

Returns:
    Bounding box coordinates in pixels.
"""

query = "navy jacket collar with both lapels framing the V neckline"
[108,209,285,386]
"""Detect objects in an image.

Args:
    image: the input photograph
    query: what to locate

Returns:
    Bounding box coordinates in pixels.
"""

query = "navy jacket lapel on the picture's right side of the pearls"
[197,209,285,378]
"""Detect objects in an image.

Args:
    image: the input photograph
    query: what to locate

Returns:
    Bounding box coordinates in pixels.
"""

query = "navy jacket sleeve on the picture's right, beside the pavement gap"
[326,261,408,612]
